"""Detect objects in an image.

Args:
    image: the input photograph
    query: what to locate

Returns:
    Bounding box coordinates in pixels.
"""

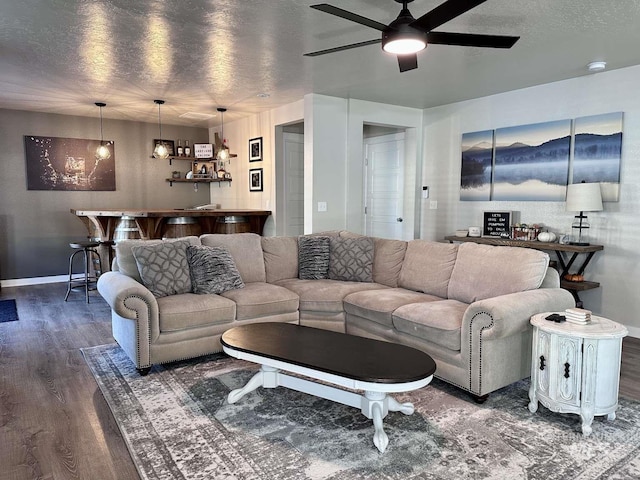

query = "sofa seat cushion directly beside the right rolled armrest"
[393,300,469,351]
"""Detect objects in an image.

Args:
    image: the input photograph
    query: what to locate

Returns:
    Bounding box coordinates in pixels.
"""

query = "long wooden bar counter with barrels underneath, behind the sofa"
[71,208,271,242]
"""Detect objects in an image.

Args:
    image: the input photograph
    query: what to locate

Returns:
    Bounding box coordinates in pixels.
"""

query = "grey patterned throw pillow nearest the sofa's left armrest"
[131,240,191,297]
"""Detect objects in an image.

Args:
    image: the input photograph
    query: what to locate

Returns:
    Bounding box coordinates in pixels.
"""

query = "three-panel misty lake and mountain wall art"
[460,112,623,201]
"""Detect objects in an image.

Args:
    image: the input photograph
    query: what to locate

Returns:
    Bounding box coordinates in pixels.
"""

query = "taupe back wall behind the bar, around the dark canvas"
[0,107,209,286]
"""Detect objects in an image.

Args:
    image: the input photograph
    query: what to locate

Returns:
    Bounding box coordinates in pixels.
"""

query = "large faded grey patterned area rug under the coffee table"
[83,344,640,480]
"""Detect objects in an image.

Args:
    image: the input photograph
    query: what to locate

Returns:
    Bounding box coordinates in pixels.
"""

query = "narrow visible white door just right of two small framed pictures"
[283,132,304,236]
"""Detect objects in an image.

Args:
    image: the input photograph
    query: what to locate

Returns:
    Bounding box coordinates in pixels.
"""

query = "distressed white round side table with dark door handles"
[529,312,628,436]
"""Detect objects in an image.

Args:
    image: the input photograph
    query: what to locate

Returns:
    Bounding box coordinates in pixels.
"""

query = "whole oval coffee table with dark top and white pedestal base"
[221,323,436,452]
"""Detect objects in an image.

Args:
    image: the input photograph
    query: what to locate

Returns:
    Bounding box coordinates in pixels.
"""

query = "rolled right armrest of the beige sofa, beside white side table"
[462,288,575,345]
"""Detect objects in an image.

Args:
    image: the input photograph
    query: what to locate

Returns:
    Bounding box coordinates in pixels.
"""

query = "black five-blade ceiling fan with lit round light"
[305,0,520,72]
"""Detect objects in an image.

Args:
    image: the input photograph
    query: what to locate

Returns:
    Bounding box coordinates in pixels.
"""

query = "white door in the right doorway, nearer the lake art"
[364,132,404,239]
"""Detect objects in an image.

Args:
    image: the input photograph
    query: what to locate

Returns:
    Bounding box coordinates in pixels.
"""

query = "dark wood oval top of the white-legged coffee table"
[220,322,436,384]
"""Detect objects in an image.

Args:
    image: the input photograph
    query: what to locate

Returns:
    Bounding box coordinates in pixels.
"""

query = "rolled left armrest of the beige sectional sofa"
[98,272,158,320]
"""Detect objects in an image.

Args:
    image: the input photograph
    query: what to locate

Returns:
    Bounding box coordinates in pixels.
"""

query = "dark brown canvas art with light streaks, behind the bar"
[24,135,116,190]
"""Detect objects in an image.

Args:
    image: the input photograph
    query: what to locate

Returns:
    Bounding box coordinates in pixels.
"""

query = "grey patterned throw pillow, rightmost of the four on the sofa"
[329,237,374,282]
